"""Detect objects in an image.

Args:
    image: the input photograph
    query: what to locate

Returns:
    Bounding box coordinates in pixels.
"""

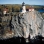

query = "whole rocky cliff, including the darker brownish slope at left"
[0,11,44,39]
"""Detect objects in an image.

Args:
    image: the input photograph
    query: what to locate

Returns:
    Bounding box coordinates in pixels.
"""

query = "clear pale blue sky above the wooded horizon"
[0,0,44,5]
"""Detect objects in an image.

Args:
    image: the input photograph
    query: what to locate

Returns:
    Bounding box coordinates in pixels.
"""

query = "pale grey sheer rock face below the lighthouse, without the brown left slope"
[11,11,44,38]
